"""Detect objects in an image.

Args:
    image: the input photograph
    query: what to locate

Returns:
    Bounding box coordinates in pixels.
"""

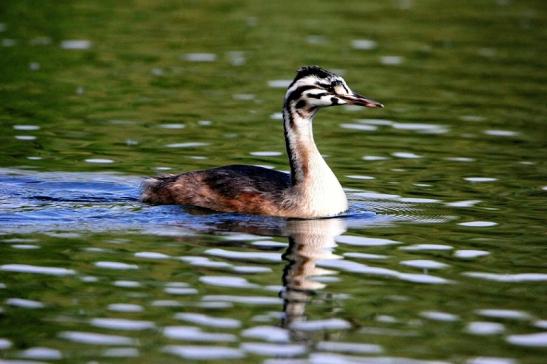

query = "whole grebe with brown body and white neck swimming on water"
[141,66,383,218]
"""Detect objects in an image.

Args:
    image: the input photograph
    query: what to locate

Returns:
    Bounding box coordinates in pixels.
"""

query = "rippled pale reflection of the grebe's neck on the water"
[280,218,346,327]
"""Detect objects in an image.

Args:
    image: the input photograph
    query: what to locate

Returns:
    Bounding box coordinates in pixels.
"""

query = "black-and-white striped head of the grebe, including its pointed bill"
[285,66,384,113]
